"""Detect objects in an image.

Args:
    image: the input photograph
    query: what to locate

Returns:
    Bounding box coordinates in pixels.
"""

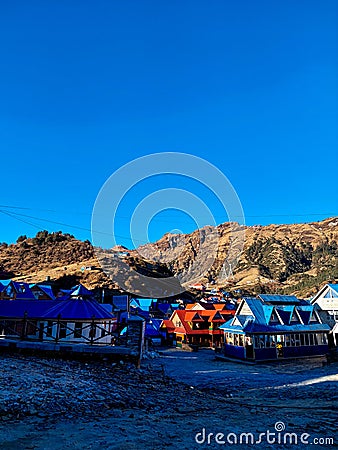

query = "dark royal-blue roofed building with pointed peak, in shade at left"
[0,285,116,344]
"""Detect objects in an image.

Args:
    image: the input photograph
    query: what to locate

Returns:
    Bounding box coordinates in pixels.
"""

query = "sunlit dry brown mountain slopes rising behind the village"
[0,218,338,296]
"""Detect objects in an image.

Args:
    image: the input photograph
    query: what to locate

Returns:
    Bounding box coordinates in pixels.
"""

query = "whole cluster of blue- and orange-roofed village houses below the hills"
[0,280,338,361]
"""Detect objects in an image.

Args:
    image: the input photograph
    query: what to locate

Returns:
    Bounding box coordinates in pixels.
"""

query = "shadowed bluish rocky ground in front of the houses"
[0,350,338,450]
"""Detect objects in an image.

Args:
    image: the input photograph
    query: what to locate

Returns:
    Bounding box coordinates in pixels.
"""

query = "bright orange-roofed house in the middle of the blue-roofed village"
[161,303,235,348]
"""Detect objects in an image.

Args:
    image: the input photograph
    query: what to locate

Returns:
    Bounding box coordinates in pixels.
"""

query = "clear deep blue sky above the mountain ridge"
[0,0,338,246]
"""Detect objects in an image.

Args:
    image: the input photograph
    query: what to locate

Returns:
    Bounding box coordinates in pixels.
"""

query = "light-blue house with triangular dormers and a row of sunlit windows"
[220,295,330,361]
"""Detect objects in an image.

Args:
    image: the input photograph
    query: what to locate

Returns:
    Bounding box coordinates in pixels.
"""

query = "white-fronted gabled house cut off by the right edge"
[311,284,338,347]
